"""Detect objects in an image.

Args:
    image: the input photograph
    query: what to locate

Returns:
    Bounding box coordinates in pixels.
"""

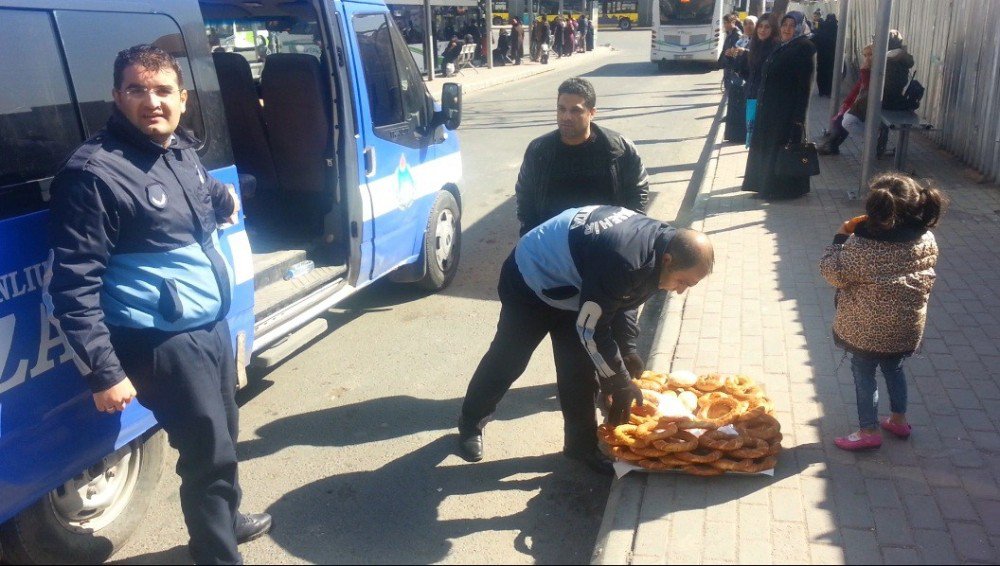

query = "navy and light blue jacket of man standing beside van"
[47,109,235,392]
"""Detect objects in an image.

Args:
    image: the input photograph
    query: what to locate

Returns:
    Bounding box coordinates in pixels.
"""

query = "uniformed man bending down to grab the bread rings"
[459,206,715,473]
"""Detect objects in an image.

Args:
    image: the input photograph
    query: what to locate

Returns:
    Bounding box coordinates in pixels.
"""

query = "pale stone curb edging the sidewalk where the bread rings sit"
[590,101,725,565]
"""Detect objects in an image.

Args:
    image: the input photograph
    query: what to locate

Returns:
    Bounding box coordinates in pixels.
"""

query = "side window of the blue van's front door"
[353,14,402,127]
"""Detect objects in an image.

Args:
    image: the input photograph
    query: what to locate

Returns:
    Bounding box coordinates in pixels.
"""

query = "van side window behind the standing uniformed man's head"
[56,11,205,140]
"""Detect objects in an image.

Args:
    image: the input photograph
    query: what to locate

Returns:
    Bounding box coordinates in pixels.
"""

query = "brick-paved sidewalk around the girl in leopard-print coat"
[593,92,1000,564]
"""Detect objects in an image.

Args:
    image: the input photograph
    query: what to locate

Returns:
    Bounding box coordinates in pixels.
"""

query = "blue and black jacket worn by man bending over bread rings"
[514,206,677,388]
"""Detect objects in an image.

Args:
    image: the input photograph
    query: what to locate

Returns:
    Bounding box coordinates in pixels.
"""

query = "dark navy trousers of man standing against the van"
[111,321,243,564]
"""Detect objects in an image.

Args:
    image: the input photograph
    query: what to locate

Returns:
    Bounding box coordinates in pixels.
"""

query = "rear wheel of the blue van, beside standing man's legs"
[0,430,167,564]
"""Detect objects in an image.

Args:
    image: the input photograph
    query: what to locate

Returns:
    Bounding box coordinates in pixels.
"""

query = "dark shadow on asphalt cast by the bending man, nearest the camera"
[267,434,610,564]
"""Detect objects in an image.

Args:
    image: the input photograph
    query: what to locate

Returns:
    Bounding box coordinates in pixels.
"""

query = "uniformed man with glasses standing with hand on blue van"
[47,45,271,564]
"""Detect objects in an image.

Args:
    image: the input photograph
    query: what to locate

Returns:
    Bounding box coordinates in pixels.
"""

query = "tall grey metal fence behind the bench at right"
[845,0,1000,182]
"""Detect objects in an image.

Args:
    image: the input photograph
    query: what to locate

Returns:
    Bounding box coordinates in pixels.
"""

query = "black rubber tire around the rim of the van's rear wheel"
[0,430,167,564]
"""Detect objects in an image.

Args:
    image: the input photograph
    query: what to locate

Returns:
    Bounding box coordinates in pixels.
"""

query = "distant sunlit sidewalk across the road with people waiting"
[424,45,615,99]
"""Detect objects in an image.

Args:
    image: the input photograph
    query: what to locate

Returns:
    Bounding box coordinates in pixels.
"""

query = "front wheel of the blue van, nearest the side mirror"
[420,191,462,291]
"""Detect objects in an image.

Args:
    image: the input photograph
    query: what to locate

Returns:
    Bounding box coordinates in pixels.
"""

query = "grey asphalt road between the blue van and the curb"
[116,31,721,564]
